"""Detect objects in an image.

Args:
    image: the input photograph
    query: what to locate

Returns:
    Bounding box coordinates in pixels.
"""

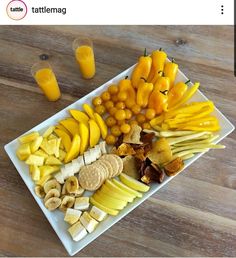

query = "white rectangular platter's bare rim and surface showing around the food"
[5,63,234,255]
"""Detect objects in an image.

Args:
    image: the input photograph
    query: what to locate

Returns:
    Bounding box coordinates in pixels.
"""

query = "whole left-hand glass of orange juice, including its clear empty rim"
[31,61,61,101]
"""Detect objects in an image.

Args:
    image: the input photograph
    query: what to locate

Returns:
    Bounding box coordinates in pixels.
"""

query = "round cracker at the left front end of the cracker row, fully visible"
[78,166,102,191]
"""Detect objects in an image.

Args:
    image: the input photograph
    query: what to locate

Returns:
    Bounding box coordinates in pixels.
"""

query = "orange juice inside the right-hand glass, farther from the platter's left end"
[75,45,96,79]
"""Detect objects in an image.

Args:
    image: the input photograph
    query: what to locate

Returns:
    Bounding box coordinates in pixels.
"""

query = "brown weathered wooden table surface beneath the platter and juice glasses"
[0,26,236,256]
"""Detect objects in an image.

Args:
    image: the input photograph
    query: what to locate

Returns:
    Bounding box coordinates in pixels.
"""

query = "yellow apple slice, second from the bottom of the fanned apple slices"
[93,191,127,210]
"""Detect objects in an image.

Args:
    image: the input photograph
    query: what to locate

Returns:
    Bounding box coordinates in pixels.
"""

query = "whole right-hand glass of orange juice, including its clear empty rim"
[72,38,96,79]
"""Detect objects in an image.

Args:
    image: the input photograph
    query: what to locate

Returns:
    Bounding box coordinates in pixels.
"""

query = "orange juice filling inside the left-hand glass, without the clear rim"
[34,68,61,101]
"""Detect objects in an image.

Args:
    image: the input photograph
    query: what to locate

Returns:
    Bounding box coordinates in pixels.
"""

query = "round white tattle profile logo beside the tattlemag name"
[7,0,27,21]
